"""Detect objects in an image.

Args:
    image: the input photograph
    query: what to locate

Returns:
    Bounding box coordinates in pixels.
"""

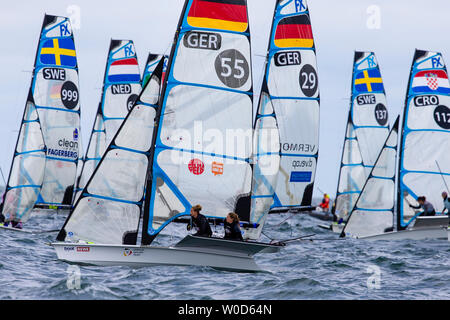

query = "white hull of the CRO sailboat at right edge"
[359,227,448,240]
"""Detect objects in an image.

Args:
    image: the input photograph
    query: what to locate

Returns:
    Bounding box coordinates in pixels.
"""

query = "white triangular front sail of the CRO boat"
[341,117,399,238]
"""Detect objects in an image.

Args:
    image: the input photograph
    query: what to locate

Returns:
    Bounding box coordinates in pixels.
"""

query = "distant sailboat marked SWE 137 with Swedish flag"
[325,51,389,232]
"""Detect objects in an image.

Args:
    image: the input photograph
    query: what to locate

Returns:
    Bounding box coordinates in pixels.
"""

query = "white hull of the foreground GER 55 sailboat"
[51,236,282,272]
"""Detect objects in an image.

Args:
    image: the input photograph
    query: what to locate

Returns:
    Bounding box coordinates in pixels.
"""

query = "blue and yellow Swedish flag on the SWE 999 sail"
[40,38,77,67]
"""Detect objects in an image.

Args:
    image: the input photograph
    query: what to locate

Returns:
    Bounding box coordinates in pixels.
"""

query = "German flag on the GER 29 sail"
[274,14,314,48]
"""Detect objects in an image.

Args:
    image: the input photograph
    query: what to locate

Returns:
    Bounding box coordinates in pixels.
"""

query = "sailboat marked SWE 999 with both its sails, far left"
[1,15,80,230]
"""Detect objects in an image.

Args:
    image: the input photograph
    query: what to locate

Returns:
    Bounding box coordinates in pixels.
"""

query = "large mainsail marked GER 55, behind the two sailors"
[142,0,253,244]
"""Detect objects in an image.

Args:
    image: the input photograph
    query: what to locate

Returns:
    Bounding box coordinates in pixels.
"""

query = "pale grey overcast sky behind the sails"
[0,0,450,200]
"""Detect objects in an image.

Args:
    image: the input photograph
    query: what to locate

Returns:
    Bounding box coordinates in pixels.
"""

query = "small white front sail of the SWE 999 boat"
[1,95,45,222]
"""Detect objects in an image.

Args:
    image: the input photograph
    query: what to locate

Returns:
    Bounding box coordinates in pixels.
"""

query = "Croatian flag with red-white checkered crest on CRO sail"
[412,70,450,94]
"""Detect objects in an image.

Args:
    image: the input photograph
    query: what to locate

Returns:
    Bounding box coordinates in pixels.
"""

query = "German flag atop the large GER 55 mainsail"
[187,0,248,32]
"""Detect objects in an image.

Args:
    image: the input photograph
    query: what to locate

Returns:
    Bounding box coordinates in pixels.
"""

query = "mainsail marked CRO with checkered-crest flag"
[397,50,450,230]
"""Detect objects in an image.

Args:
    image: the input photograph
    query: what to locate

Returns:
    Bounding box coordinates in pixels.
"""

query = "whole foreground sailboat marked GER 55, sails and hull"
[52,0,280,271]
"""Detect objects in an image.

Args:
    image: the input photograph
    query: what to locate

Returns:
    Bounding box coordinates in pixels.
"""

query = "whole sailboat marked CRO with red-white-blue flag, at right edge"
[341,50,450,240]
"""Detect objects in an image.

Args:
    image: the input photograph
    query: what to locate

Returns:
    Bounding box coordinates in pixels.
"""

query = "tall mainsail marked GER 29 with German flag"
[265,0,319,207]
